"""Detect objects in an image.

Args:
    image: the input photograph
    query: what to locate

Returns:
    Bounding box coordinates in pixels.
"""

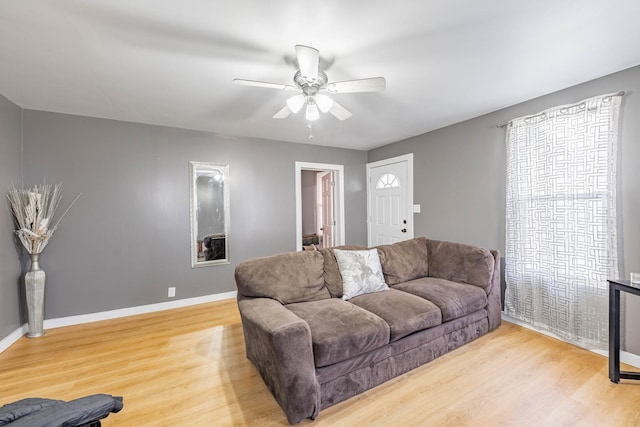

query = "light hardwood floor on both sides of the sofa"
[0,300,640,427]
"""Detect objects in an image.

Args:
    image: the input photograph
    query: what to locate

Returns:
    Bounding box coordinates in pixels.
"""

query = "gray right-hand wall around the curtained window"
[368,67,640,354]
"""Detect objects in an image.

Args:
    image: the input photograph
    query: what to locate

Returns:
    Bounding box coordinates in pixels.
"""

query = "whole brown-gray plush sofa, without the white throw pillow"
[235,238,501,424]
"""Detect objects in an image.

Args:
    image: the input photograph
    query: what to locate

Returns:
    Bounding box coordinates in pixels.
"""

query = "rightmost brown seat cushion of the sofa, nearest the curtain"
[393,277,487,322]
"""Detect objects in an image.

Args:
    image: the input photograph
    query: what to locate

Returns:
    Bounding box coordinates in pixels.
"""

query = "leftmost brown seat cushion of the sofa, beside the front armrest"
[285,298,389,367]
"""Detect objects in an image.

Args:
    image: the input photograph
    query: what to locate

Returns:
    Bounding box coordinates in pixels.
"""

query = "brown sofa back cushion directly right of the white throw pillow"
[377,237,429,286]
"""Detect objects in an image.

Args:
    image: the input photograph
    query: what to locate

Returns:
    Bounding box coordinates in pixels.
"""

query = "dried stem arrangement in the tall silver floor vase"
[7,184,80,254]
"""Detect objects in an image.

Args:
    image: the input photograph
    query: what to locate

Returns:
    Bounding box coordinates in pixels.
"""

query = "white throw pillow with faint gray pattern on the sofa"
[333,249,389,300]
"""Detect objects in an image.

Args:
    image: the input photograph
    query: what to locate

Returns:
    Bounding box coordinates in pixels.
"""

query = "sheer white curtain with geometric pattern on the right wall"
[505,94,621,349]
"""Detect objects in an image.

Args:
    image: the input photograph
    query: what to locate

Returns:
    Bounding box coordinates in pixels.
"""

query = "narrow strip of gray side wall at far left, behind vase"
[0,95,22,340]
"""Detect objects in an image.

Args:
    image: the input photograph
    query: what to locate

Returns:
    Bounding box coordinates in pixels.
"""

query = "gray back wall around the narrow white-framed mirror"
[23,110,367,319]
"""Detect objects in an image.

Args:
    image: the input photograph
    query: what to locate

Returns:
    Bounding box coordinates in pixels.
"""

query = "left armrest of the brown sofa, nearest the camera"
[238,296,320,424]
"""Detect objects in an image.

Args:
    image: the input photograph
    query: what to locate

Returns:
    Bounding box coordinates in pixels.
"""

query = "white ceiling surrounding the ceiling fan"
[0,0,640,150]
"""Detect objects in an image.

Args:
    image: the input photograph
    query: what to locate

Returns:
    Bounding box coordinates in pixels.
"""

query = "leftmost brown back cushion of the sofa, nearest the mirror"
[235,251,331,304]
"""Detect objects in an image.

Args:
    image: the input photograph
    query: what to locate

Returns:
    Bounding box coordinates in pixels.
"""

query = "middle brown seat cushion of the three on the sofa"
[350,289,442,341]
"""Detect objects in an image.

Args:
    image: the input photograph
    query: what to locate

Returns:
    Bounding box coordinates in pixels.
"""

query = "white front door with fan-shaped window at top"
[367,154,413,247]
